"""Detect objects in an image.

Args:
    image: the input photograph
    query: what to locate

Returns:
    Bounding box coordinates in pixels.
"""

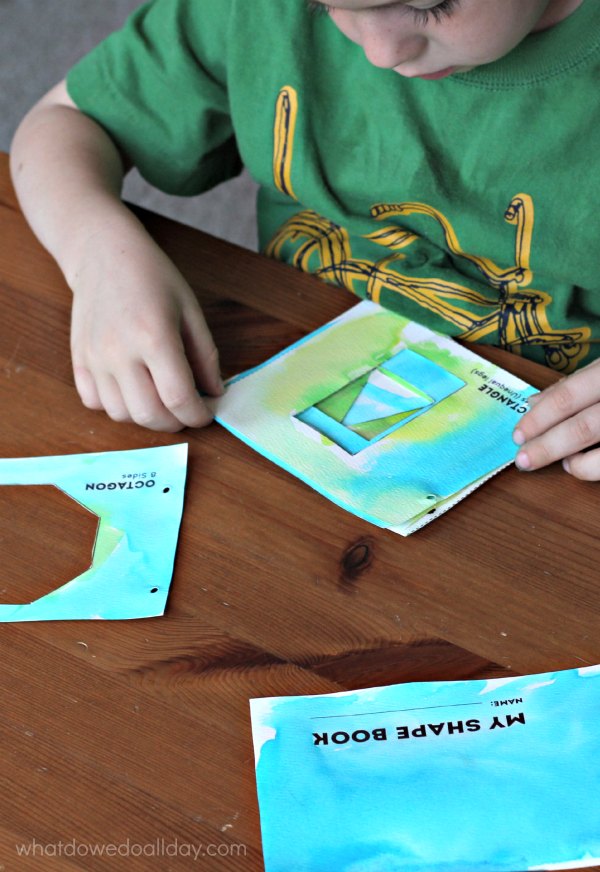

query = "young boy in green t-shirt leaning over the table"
[11,0,600,480]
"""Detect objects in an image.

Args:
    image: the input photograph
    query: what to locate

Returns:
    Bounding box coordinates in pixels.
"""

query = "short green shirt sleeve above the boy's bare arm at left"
[67,0,241,195]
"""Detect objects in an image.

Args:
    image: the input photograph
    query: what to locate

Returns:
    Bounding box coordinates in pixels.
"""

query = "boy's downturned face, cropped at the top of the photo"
[310,0,583,79]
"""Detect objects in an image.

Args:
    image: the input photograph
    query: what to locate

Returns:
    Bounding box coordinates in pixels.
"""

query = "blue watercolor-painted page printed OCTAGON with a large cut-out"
[0,444,187,622]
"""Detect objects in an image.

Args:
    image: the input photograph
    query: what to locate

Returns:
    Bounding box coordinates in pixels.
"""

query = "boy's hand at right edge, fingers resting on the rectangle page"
[513,360,600,481]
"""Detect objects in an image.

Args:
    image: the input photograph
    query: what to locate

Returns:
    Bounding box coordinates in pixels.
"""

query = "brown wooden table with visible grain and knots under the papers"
[0,156,600,872]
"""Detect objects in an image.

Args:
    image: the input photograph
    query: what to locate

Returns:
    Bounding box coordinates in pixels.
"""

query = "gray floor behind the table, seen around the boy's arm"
[0,0,256,248]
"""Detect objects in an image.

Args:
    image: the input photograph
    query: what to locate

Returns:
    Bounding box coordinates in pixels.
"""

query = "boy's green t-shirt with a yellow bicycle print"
[67,0,600,372]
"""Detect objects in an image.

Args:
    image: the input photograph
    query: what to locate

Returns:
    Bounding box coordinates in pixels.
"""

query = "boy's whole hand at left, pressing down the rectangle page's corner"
[69,228,223,432]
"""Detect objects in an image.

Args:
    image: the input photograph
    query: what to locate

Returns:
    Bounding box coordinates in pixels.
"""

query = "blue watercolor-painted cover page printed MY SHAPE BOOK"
[251,666,600,872]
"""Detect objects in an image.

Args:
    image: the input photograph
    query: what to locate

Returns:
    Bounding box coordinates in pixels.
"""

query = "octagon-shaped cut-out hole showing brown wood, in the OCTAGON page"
[0,484,99,605]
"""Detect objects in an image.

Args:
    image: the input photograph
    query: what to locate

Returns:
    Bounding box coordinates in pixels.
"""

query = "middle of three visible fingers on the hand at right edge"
[515,404,600,470]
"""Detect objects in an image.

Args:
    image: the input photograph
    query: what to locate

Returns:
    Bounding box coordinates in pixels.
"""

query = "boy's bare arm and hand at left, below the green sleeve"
[10,82,222,431]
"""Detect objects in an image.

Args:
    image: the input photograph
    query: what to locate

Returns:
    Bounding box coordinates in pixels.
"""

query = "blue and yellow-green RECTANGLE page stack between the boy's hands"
[215,301,536,535]
